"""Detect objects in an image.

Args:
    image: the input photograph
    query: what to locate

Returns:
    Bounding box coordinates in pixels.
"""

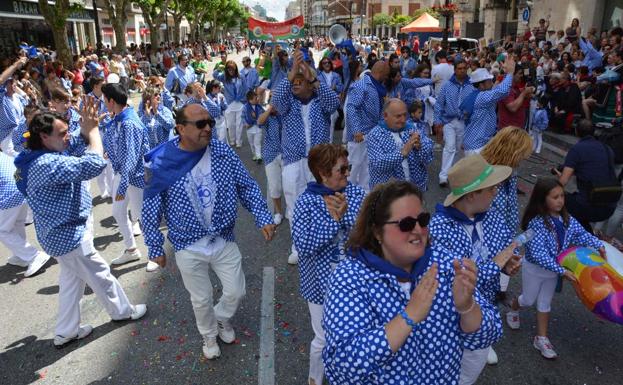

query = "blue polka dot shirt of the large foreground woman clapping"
[323,247,502,385]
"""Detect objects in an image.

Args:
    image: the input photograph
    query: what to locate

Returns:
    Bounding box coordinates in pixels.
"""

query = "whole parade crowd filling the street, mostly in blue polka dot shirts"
[0,19,623,385]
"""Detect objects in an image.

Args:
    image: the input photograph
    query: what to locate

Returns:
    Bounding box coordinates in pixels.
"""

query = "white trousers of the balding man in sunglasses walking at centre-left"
[175,242,245,337]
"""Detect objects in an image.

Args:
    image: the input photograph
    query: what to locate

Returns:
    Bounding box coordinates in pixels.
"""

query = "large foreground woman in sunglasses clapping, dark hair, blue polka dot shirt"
[323,181,502,385]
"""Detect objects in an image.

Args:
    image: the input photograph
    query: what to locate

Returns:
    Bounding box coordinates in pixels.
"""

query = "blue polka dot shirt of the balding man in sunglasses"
[142,138,273,259]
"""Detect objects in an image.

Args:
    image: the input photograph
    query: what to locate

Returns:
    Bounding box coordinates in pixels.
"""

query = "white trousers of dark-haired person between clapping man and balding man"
[112,174,143,249]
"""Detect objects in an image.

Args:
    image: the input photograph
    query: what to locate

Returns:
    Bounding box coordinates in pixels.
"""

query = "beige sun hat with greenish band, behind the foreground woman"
[443,154,513,206]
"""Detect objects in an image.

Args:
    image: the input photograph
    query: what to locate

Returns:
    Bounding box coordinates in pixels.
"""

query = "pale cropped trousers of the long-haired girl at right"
[517,260,558,313]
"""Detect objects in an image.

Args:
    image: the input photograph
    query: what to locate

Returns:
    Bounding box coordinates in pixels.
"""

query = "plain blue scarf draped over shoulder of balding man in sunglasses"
[144,138,206,199]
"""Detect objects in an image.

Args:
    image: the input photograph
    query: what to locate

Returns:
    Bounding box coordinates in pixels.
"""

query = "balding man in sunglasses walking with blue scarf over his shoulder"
[143,104,275,359]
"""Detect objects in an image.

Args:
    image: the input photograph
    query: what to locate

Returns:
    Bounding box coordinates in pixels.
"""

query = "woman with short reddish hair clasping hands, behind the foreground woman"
[292,143,365,385]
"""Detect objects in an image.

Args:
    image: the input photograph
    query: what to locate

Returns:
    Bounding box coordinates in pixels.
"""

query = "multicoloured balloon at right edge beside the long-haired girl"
[557,245,623,324]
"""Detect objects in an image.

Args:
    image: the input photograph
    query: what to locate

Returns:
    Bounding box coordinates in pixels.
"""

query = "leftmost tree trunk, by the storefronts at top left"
[39,0,82,68]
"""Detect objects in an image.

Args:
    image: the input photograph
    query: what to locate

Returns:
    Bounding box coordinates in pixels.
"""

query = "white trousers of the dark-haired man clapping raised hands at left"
[55,226,134,337]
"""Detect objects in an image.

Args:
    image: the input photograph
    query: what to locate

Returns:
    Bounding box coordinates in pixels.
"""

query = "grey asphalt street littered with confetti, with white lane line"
[0,49,623,385]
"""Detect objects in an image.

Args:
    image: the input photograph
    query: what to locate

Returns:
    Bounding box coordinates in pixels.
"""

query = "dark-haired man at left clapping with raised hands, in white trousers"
[15,98,147,348]
